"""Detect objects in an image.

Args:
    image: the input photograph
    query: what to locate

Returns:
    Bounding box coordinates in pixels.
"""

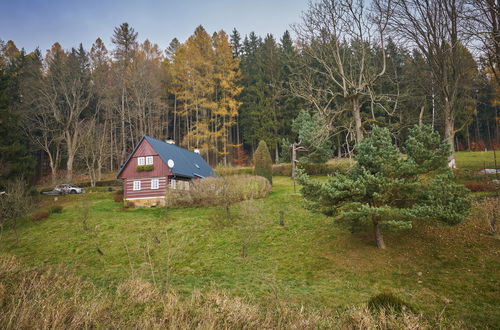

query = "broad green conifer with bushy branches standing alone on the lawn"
[299,126,470,248]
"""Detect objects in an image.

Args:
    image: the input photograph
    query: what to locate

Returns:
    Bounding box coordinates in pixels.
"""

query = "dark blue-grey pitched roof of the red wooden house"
[120,135,213,178]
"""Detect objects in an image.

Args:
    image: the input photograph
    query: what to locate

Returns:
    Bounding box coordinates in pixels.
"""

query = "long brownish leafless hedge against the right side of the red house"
[167,175,271,206]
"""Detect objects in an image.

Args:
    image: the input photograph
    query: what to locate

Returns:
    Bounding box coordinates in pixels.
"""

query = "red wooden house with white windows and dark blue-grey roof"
[117,135,213,207]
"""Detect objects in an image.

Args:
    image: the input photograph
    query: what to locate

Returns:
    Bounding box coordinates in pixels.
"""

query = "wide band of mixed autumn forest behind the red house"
[0,0,500,186]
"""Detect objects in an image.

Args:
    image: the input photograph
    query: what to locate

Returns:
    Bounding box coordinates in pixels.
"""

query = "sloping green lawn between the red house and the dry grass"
[0,175,500,328]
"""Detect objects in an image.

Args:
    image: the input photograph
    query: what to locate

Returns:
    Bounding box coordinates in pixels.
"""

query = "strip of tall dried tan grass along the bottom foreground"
[0,256,452,329]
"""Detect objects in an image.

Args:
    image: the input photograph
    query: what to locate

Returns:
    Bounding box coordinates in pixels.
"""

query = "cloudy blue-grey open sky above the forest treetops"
[0,0,307,52]
